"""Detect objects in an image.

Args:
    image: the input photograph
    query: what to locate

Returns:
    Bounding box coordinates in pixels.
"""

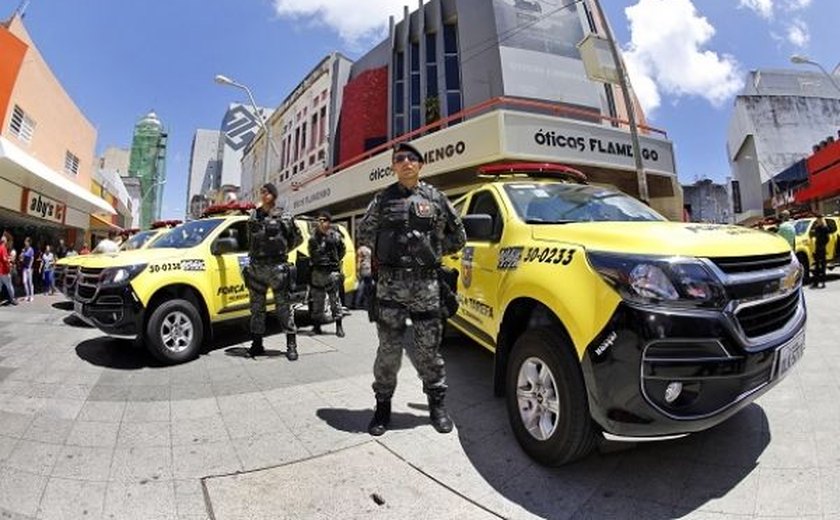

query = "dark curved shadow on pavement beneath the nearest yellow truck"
[436,338,770,519]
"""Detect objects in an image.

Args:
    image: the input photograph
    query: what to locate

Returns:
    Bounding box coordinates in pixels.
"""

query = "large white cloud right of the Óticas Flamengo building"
[624,0,743,112]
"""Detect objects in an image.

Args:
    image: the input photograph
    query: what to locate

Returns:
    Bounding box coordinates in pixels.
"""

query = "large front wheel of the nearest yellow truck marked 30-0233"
[506,327,596,466]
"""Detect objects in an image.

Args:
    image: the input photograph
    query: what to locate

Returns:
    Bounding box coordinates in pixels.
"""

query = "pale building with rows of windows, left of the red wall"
[242,52,352,200]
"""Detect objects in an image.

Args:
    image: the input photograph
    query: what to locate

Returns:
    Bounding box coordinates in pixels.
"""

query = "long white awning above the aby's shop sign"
[0,137,117,215]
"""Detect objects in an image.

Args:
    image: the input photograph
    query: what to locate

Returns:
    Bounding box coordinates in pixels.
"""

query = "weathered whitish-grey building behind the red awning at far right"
[726,70,840,223]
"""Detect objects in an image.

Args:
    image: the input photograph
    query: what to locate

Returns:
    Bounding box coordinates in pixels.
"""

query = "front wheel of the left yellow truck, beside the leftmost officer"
[146,299,204,364]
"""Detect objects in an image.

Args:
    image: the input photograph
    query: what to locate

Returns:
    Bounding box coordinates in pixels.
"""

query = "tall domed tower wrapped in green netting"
[128,111,167,228]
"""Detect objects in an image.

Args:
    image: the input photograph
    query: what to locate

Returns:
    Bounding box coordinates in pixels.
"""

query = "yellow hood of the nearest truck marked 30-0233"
[532,222,790,257]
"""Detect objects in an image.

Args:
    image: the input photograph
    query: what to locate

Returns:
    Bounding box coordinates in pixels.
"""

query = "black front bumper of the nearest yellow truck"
[581,290,806,440]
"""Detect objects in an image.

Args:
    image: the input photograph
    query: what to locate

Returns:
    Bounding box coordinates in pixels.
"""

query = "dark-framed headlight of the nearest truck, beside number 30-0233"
[586,252,726,308]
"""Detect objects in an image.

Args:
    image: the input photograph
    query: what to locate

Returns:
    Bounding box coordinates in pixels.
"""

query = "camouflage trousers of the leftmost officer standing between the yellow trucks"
[242,263,296,335]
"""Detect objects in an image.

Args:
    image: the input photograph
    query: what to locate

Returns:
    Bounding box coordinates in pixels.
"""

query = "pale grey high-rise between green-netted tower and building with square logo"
[186,129,222,218]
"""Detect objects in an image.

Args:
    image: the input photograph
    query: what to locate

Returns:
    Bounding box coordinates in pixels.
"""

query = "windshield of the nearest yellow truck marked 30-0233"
[505,183,666,224]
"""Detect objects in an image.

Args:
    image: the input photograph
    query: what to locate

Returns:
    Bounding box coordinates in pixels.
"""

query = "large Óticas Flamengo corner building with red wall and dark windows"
[266,0,683,232]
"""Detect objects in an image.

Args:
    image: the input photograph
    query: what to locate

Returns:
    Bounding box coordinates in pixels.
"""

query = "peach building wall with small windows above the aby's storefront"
[0,17,96,189]
